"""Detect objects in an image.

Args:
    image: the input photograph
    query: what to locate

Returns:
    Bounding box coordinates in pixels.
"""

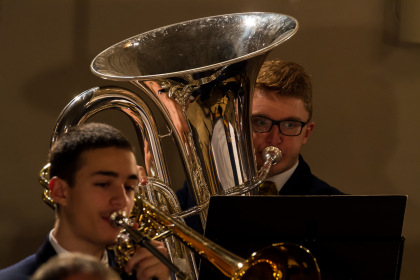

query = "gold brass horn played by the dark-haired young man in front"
[111,195,321,280]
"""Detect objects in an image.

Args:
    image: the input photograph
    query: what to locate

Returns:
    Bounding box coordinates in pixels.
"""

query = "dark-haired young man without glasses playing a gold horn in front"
[0,123,170,280]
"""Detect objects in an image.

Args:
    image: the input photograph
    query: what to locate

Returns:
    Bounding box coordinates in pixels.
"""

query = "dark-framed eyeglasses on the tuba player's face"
[251,116,309,136]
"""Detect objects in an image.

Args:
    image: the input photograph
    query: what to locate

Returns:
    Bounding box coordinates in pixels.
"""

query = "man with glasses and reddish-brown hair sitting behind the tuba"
[251,60,343,195]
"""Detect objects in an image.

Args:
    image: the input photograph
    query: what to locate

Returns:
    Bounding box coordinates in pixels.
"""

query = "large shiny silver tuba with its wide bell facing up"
[40,13,298,279]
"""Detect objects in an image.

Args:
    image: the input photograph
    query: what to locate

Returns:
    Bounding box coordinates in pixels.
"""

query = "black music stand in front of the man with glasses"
[199,195,407,280]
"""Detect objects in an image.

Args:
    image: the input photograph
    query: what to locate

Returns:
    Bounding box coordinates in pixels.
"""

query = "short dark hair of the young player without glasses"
[49,123,134,186]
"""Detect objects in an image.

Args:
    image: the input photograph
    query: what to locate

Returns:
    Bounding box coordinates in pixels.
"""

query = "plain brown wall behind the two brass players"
[0,0,420,280]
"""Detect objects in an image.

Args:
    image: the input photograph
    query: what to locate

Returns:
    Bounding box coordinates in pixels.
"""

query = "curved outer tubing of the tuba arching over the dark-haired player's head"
[39,87,196,275]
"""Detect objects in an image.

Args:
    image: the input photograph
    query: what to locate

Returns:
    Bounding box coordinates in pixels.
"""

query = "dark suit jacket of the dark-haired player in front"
[0,238,136,280]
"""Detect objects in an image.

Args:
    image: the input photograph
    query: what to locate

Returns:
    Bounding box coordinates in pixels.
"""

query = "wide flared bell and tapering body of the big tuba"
[91,13,298,221]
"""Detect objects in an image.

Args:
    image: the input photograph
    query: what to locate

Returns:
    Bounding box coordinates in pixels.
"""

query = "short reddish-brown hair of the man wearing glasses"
[256,59,312,119]
